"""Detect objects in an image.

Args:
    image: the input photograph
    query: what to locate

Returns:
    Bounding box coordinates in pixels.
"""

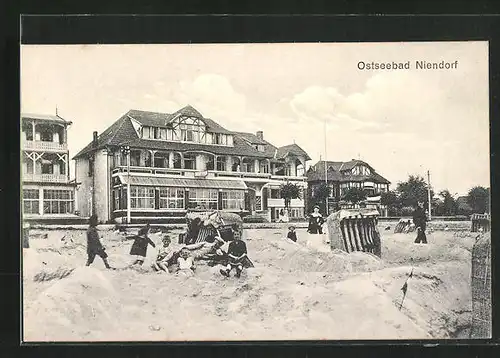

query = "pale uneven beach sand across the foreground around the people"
[23,229,474,341]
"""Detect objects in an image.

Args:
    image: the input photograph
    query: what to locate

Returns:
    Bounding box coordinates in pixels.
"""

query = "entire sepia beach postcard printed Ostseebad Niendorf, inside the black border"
[19,41,492,343]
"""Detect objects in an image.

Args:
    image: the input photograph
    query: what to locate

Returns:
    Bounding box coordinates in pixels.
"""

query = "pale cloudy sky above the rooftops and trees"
[21,42,490,195]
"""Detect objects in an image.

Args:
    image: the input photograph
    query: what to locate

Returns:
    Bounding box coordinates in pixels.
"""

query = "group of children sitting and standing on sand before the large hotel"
[86,211,253,278]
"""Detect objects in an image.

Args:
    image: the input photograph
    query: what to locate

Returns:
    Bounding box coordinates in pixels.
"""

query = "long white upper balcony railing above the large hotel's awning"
[112,165,307,181]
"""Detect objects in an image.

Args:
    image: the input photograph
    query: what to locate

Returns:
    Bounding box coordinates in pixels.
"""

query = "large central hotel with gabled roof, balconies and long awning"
[74,106,311,223]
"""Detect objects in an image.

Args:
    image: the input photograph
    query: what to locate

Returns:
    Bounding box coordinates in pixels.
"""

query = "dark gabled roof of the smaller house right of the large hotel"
[307,159,391,184]
